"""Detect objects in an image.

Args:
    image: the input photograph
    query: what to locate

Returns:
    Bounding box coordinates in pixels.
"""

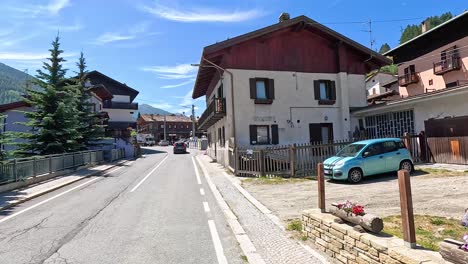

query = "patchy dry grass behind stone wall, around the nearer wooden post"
[383,215,468,251]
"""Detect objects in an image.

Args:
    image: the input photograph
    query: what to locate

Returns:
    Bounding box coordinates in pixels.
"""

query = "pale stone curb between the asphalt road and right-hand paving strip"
[195,157,265,264]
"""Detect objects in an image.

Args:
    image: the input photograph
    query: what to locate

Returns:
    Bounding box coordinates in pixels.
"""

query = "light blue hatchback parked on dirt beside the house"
[323,138,414,183]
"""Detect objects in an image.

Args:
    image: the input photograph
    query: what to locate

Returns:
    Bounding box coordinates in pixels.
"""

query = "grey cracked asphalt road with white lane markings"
[0,147,243,264]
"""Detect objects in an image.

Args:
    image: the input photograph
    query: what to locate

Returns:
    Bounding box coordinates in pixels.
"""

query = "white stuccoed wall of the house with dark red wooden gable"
[208,69,367,145]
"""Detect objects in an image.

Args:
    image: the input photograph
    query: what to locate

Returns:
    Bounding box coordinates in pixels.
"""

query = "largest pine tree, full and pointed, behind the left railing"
[18,36,82,154]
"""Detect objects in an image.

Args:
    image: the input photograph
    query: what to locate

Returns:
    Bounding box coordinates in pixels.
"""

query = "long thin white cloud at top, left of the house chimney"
[142,3,263,23]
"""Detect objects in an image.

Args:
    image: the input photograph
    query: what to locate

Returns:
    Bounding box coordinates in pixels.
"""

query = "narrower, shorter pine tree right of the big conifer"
[76,52,105,146]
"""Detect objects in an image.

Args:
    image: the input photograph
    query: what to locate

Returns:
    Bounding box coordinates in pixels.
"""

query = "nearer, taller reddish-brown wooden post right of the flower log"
[398,170,416,248]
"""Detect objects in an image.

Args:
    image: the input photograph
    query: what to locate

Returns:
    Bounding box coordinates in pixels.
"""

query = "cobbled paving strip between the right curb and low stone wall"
[200,156,323,264]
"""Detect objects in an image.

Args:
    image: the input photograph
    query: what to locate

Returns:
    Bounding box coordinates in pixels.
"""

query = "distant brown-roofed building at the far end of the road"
[137,114,196,141]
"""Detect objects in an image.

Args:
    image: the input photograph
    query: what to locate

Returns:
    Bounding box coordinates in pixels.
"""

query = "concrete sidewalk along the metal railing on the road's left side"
[0,160,127,211]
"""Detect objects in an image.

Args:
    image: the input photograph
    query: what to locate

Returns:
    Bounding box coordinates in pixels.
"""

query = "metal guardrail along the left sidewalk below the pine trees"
[0,149,108,184]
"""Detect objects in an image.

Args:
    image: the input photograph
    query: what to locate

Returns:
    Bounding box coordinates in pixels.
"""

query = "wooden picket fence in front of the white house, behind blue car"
[229,140,352,177]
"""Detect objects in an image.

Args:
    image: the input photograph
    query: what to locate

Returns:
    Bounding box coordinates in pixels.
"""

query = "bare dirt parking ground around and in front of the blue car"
[242,173,468,222]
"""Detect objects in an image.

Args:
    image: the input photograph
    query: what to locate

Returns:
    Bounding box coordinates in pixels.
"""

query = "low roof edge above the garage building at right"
[351,84,468,116]
